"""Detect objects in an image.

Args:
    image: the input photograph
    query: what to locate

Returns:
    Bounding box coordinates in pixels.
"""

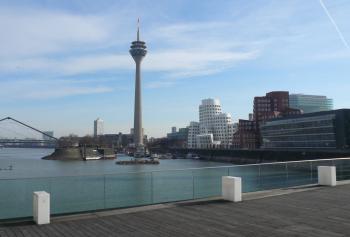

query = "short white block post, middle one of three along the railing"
[222,176,242,202]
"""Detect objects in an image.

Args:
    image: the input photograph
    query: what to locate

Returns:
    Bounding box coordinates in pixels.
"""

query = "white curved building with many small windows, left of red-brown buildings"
[188,99,234,148]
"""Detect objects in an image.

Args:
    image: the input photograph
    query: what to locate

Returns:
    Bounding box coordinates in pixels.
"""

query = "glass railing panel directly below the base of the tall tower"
[105,173,152,208]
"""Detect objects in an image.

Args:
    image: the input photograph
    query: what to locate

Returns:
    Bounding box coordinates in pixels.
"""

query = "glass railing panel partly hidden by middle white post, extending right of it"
[229,165,261,193]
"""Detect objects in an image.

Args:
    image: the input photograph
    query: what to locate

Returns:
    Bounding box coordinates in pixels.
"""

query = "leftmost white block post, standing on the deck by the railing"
[33,191,50,225]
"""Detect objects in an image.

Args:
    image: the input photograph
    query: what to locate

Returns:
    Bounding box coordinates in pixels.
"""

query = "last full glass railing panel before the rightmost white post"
[287,161,313,187]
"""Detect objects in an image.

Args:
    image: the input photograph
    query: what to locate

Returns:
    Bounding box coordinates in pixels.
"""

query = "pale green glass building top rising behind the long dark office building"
[289,94,333,113]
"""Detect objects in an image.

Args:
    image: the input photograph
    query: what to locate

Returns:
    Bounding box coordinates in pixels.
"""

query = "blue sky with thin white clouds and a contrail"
[0,0,350,137]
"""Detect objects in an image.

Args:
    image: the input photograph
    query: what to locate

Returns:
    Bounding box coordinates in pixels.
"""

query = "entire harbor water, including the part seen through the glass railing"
[0,148,350,220]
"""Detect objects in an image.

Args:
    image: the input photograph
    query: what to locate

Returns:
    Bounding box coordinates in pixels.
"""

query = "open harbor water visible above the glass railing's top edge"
[0,148,228,179]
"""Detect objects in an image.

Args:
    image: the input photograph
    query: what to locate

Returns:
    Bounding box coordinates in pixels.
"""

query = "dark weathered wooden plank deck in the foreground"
[0,185,350,237]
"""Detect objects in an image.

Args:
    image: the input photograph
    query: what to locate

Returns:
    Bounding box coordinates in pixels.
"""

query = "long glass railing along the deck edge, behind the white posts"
[0,158,350,219]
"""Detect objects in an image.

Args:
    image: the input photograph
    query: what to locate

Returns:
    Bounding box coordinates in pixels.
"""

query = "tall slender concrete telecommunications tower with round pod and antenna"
[129,20,147,155]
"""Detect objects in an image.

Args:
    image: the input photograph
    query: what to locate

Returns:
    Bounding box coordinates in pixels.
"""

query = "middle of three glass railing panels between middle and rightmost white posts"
[260,163,287,190]
